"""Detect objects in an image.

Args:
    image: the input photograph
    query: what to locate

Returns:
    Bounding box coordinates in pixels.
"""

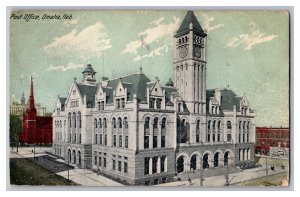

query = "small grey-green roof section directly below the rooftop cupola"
[77,84,97,108]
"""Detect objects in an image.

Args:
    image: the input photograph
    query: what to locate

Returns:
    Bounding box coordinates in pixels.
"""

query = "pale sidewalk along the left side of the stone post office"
[10,147,123,186]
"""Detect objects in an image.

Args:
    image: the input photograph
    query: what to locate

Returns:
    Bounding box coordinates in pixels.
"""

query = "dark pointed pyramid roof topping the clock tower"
[175,11,206,37]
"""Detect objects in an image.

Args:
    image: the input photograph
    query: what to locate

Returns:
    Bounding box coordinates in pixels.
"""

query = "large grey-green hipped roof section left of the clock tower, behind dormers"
[104,73,150,103]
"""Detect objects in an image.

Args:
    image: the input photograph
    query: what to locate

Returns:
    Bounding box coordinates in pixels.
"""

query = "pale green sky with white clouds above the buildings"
[9,10,289,127]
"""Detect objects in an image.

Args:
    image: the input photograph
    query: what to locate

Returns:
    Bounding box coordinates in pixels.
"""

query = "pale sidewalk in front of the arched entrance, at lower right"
[157,166,287,187]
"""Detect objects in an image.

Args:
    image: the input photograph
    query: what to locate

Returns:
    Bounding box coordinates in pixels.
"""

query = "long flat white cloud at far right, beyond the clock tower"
[225,28,277,51]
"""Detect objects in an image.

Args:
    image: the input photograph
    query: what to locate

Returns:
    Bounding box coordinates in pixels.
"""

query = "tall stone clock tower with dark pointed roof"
[173,11,207,114]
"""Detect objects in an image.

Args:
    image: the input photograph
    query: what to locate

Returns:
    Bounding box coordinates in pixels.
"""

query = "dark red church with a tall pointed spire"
[19,78,53,144]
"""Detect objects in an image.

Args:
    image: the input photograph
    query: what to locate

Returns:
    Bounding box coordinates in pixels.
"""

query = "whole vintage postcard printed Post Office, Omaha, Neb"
[9,9,290,188]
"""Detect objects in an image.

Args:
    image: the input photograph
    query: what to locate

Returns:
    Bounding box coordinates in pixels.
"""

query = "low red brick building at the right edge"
[255,127,290,156]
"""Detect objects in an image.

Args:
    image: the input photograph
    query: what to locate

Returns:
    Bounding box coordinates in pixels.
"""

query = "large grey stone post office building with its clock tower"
[53,11,255,185]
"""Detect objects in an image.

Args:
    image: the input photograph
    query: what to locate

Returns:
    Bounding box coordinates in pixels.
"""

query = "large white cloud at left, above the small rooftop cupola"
[44,22,111,60]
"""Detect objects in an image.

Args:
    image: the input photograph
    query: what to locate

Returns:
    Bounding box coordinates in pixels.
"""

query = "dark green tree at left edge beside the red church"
[9,115,23,152]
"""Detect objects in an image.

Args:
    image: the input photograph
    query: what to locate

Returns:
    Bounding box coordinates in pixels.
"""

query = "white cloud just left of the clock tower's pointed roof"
[122,17,181,56]
